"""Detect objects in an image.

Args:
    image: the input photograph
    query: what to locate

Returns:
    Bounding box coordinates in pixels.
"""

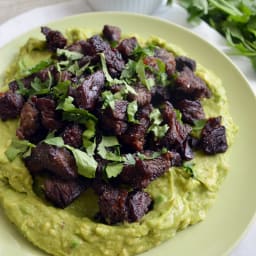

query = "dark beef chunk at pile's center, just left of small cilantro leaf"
[100,100,128,135]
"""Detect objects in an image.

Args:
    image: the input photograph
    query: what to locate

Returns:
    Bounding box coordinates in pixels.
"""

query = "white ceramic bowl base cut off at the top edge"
[87,0,167,14]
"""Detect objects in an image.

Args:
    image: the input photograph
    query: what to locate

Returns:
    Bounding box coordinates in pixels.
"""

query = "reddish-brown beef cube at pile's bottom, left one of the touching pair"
[99,186,128,224]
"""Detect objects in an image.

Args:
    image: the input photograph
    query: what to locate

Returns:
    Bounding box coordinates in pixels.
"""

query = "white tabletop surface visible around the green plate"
[0,0,256,256]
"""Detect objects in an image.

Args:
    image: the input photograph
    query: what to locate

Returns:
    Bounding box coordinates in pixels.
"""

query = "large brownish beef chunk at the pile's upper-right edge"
[175,67,211,100]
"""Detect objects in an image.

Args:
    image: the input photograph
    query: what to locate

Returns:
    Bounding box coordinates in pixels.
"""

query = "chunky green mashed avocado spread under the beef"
[0,29,237,256]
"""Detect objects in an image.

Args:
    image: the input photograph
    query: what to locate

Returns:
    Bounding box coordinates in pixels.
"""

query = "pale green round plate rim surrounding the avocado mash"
[0,13,256,256]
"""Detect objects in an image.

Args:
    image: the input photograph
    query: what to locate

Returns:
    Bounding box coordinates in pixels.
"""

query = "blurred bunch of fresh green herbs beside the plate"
[178,0,256,70]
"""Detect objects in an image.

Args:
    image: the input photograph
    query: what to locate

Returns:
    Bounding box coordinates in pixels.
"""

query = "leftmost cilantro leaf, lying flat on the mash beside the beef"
[4,139,35,162]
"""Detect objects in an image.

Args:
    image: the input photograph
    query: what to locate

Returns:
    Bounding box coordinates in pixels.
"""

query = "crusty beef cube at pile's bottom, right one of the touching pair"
[126,191,152,222]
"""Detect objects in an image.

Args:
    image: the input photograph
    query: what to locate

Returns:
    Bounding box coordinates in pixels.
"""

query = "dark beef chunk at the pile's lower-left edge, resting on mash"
[43,177,86,208]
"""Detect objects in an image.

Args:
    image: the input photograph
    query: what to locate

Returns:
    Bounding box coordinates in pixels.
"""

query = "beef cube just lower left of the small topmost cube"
[84,35,110,56]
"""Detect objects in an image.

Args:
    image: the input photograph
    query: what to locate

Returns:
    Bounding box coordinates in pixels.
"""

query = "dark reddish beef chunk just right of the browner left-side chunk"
[36,97,62,131]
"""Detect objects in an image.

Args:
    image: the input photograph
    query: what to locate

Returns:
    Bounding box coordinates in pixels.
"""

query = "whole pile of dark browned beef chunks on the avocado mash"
[0,25,227,224]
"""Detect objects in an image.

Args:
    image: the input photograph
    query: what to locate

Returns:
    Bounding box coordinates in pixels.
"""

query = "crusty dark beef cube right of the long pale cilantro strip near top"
[104,49,125,77]
